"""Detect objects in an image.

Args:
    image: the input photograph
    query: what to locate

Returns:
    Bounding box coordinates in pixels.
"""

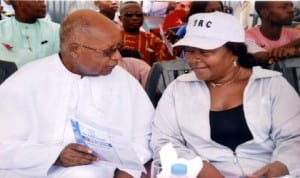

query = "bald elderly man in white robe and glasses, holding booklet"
[0,10,154,178]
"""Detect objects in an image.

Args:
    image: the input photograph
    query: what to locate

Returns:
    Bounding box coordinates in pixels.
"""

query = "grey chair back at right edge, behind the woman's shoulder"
[278,57,300,94]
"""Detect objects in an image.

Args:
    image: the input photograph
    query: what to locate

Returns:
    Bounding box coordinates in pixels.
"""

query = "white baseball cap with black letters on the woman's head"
[173,11,245,49]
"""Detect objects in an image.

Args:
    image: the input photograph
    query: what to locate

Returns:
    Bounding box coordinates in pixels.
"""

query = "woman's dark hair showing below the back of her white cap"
[225,42,267,68]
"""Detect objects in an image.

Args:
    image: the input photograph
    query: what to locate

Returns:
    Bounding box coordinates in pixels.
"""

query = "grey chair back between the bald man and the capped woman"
[145,58,191,107]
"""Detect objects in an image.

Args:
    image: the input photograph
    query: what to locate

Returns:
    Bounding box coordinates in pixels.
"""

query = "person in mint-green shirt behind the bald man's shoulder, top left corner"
[0,0,59,67]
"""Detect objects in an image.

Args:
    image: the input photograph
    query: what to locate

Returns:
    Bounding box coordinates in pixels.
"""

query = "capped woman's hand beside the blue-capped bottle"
[197,161,224,178]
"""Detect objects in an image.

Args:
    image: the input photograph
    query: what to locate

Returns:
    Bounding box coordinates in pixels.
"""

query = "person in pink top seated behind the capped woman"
[246,1,300,64]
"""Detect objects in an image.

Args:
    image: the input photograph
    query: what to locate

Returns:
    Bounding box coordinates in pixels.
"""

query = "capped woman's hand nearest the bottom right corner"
[248,161,289,178]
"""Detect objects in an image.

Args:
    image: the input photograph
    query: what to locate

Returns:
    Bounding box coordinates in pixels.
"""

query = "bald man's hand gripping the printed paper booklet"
[55,143,97,167]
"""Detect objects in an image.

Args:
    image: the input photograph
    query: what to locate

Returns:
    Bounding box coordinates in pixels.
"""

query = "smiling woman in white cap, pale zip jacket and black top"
[151,12,300,178]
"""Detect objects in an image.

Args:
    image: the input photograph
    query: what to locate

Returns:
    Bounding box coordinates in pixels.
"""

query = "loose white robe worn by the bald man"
[0,54,154,178]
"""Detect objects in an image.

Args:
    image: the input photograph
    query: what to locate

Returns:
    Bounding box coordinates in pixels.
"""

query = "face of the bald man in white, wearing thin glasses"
[70,29,122,76]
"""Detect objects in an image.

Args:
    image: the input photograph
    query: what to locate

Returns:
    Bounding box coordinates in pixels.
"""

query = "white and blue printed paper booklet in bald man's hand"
[71,119,145,171]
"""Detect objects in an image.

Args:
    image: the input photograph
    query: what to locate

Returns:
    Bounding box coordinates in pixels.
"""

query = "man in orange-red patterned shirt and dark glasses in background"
[120,1,173,66]
